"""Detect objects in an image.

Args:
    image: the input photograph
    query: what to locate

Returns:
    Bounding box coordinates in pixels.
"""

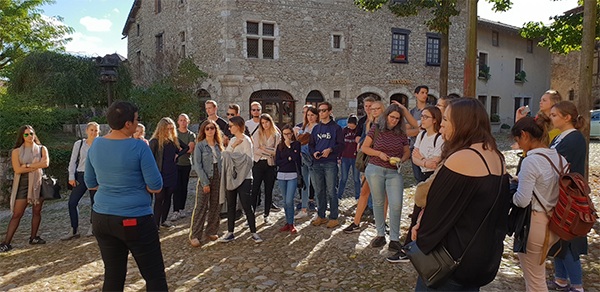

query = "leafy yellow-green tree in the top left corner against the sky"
[0,0,73,71]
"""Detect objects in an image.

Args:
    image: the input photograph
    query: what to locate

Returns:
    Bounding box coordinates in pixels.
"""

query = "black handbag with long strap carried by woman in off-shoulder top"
[403,154,504,289]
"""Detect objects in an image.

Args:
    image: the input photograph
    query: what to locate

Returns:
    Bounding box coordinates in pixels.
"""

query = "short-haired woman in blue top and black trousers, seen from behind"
[84,102,168,291]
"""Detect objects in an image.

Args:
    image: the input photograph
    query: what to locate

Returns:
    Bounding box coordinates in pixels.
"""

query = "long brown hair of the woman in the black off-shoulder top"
[442,97,500,159]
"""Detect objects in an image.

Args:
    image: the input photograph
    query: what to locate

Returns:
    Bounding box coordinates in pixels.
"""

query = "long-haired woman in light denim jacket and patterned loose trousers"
[190,120,224,247]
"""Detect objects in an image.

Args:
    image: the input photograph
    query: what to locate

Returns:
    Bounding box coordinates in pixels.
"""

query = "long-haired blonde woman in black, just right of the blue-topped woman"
[150,117,189,228]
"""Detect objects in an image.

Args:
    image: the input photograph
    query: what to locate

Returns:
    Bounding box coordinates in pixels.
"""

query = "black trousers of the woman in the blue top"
[92,212,168,292]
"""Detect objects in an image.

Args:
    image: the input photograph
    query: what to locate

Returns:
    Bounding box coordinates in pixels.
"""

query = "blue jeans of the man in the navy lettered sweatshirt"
[310,162,339,220]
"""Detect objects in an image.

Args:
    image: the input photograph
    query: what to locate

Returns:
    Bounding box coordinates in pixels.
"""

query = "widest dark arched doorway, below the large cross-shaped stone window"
[248,90,296,128]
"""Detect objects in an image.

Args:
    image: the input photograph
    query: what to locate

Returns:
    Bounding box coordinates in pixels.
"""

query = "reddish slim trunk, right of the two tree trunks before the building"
[463,0,478,98]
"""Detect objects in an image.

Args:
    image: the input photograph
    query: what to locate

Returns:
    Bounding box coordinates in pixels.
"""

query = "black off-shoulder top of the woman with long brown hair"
[417,153,510,287]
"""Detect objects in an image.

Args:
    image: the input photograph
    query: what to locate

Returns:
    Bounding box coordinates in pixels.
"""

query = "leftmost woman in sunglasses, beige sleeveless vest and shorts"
[0,125,50,253]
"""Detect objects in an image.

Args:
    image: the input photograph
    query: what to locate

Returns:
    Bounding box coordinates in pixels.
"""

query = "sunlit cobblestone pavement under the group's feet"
[0,142,600,291]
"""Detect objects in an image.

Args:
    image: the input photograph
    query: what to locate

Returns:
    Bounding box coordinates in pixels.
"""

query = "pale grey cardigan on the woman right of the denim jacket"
[219,151,254,204]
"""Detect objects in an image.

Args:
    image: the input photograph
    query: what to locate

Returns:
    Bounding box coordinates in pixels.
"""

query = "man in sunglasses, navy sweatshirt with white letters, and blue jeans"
[308,101,344,228]
